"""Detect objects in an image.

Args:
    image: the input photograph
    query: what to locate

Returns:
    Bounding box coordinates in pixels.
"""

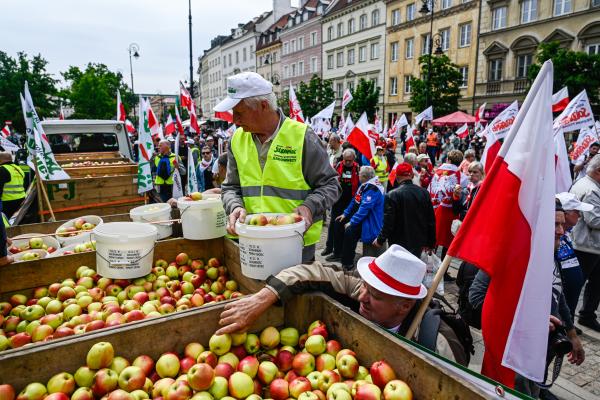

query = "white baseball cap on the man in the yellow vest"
[213,72,273,112]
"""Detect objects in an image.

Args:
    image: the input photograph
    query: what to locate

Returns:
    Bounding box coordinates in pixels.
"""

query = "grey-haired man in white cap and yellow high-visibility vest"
[214,72,341,262]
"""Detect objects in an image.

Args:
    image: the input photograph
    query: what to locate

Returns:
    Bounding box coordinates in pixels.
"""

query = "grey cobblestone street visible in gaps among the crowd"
[316,224,600,400]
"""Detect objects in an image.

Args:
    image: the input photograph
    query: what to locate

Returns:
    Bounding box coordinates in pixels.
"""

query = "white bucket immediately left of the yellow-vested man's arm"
[177,196,227,240]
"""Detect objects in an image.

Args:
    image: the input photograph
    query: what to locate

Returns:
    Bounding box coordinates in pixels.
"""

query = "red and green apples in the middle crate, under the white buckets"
[0,253,242,352]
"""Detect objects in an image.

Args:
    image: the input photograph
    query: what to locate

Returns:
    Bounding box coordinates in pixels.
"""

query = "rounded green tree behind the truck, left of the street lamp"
[61,63,137,119]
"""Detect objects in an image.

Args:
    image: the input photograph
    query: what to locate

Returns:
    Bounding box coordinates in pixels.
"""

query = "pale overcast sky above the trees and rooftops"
[0,0,290,94]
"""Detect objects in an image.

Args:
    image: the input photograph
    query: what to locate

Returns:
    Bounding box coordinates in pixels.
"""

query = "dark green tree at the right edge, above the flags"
[527,42,600,105]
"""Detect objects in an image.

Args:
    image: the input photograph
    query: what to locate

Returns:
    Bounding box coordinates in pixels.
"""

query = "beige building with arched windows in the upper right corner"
[476,0,600,109]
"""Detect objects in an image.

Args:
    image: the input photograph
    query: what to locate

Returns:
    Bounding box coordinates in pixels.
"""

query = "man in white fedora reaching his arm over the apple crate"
[216,244,469,365]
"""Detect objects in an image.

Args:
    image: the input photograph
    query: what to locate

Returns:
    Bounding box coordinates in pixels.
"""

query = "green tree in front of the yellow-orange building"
[408,54,462,116]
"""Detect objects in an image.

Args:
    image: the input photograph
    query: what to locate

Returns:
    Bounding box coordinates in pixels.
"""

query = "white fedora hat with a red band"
[357,244,427,299]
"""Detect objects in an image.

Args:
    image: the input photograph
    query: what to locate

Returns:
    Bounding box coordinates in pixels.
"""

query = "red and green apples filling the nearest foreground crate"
[0,321,412,400]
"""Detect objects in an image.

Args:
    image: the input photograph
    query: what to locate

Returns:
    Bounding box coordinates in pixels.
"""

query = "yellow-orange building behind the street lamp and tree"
[384,0,478,124]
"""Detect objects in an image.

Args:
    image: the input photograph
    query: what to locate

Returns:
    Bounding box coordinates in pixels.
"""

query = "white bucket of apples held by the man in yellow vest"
[235,213,306,280]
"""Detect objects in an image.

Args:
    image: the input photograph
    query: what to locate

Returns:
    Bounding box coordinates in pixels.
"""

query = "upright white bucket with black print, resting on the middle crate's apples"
[93,222,158,279]
